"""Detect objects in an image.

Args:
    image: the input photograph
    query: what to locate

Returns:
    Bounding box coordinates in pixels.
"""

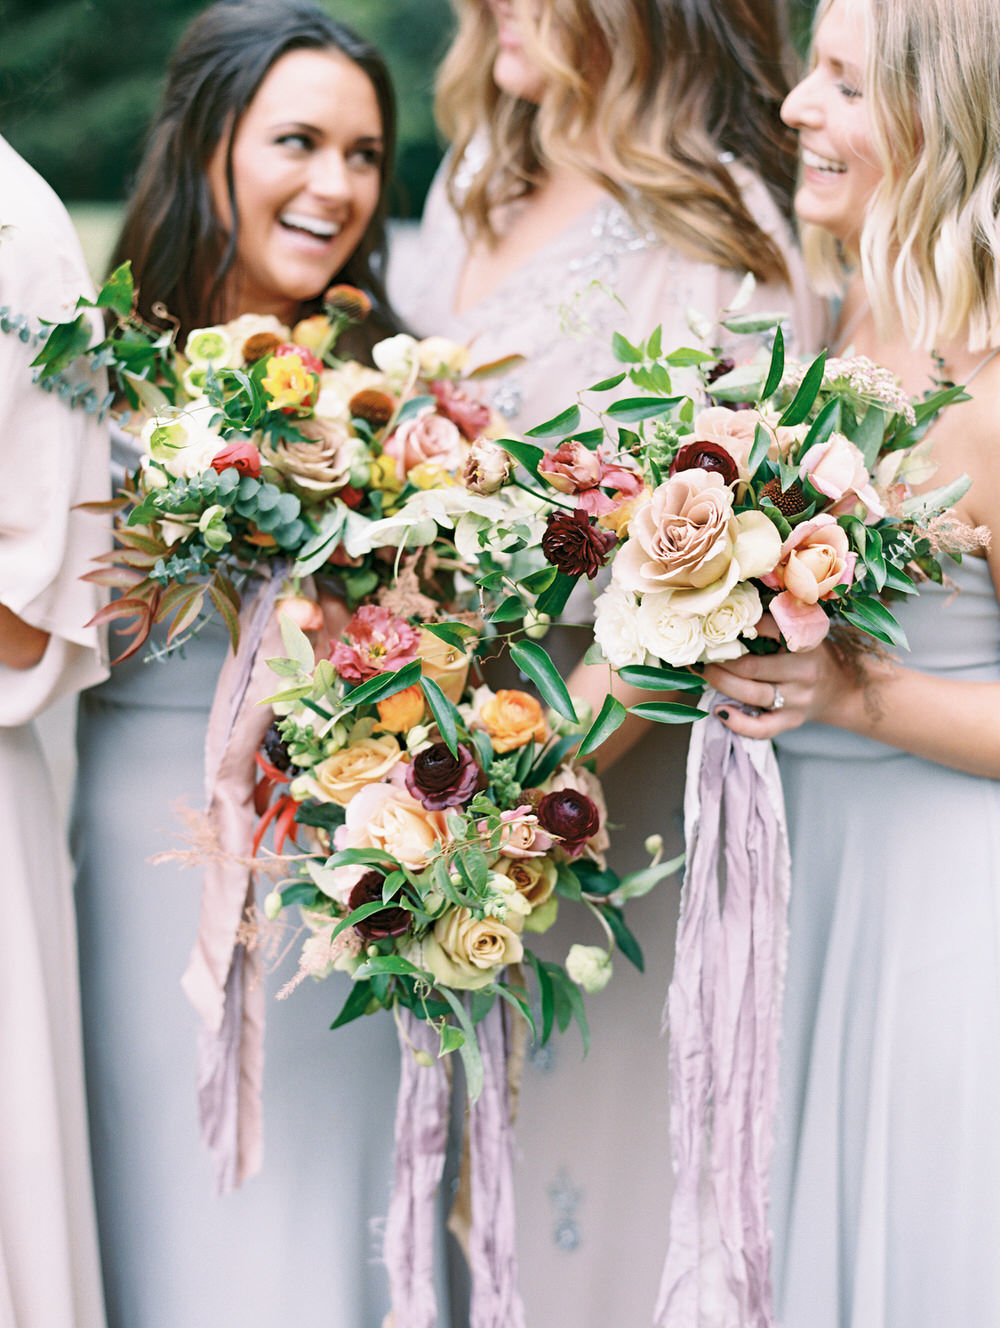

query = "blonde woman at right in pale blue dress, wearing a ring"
[705,0,1000,1328]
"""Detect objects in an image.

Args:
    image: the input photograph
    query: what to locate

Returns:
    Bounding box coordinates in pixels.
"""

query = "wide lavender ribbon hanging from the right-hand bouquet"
[655,692,789,1328]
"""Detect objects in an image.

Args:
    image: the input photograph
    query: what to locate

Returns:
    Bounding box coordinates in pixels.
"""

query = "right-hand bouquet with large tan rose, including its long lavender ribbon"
[470,287,980,1328]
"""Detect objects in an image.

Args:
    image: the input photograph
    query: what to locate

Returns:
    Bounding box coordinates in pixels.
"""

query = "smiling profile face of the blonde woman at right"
[781,0,882,252]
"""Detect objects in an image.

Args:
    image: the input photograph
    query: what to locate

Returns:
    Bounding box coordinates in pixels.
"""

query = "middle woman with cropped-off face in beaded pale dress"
[393,0,822,1328]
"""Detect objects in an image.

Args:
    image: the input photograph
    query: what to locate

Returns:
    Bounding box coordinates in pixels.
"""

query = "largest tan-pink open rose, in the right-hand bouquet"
[612,470,781,614]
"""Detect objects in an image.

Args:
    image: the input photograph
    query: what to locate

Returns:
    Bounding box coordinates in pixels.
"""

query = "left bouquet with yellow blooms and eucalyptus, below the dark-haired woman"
[27,264,526,657]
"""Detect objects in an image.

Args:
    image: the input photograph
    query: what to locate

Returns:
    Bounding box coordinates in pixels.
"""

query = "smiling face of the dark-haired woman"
[207,49,382,323]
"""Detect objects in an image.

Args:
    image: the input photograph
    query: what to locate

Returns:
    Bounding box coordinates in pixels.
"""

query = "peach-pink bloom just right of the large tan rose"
[761,513,858,651]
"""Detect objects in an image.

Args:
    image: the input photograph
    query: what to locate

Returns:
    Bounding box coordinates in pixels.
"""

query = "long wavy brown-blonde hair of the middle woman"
[437,0,794,280]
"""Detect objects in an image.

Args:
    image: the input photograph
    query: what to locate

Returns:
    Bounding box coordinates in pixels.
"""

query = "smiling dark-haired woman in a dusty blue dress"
[73,0,427,1328]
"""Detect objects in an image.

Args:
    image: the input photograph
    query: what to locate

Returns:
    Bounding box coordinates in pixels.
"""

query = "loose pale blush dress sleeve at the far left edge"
[0,145,110,725]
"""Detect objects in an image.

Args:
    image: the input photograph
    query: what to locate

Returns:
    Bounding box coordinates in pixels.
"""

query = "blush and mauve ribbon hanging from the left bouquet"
[181,568,283,1194]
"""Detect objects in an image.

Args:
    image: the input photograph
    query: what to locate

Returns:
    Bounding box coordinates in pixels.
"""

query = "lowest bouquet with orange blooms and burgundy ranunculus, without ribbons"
[255,604,679,1098]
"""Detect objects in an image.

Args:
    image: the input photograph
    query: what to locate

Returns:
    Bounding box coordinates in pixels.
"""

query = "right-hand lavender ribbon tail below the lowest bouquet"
[469,999,525,1328]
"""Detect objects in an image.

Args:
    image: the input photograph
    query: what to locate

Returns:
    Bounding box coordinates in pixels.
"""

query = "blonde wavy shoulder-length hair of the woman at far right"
[802,0,1000,351]
